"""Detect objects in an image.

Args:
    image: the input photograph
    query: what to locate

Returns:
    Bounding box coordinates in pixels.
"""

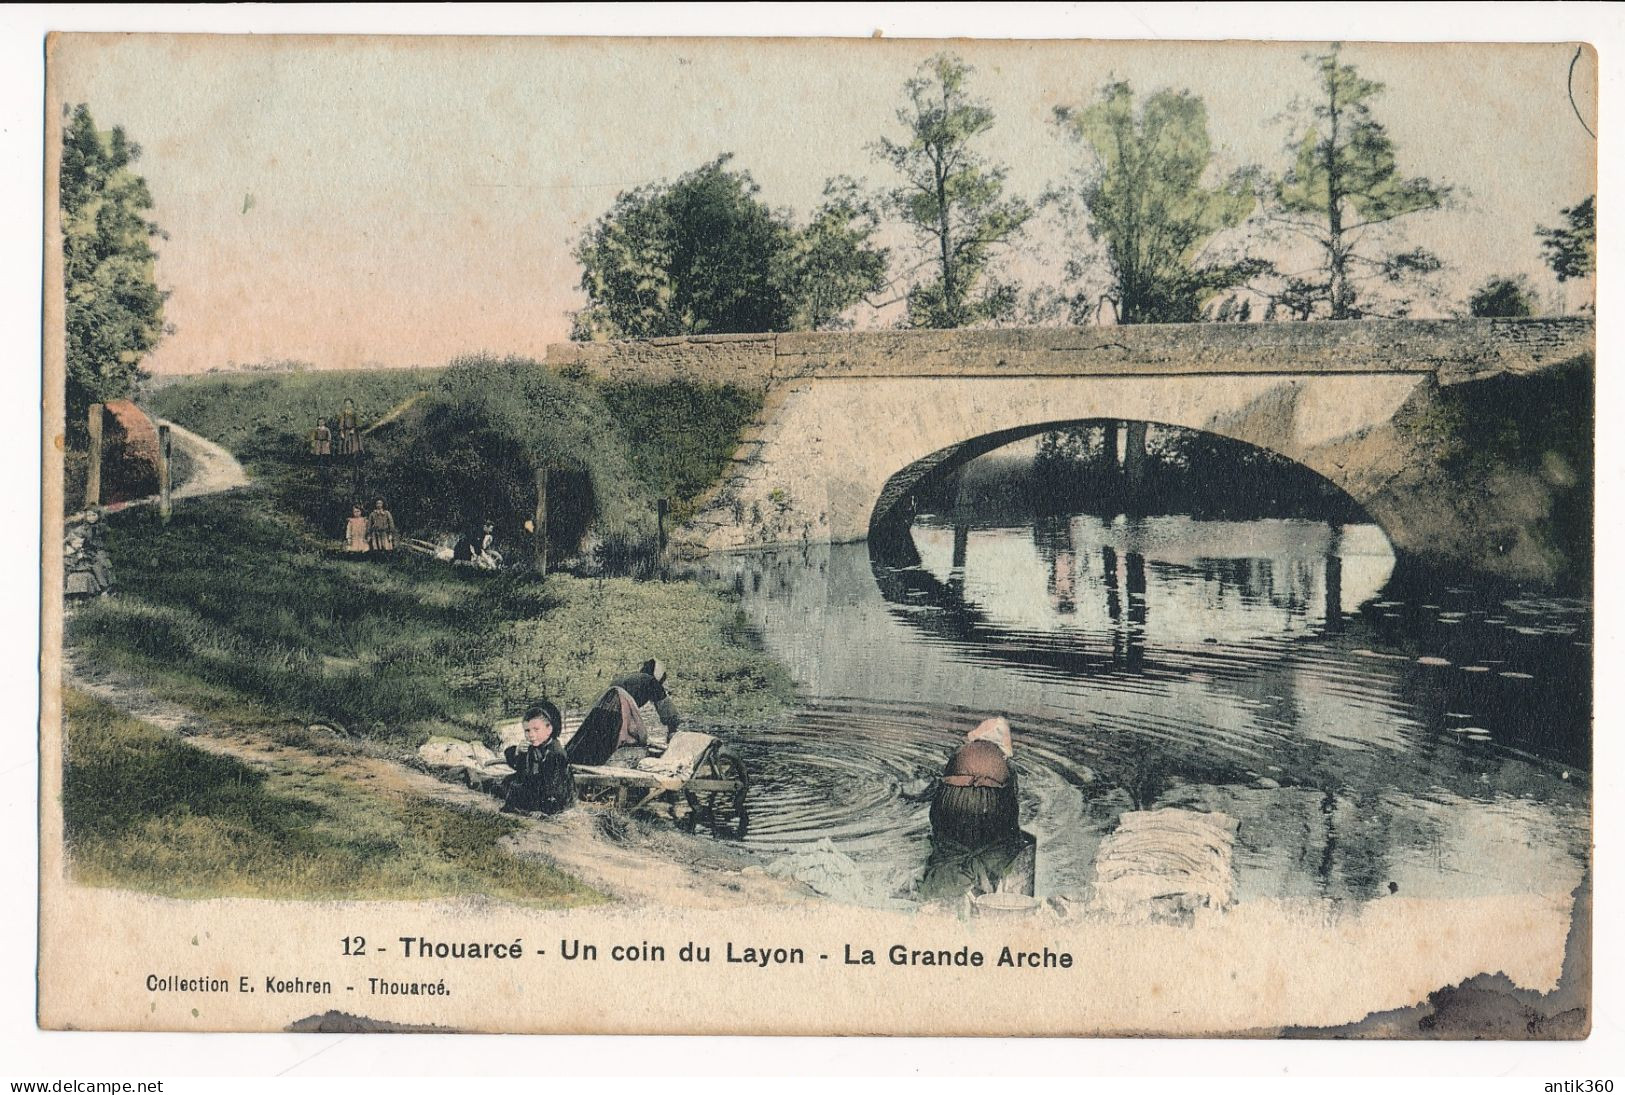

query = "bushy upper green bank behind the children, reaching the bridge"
[145,356,761,545]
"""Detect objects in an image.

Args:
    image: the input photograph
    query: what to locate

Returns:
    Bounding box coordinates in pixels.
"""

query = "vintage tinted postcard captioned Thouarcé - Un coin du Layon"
[37,34,1597,1040]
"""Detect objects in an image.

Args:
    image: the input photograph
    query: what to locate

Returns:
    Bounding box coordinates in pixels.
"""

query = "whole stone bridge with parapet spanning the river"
[546,318,1594,577]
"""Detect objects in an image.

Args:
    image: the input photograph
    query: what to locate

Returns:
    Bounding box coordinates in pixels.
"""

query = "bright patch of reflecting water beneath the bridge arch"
[897,515,1394,671]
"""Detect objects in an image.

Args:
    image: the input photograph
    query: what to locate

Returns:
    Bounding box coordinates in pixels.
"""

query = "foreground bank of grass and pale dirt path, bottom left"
[63,653,813,908]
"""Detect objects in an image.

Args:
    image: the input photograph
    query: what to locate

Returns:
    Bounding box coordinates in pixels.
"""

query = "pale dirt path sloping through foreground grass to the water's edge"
[62,650,817,908]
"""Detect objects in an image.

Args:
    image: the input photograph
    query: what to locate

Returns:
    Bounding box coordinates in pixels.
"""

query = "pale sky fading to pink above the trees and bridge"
[47,34,1596,374]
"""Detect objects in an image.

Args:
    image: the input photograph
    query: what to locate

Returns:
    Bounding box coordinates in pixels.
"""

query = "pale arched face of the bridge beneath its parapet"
[700,370,1432,549]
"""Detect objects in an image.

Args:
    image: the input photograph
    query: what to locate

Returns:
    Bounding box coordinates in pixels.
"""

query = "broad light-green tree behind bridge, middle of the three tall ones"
[1055,81,1263,323]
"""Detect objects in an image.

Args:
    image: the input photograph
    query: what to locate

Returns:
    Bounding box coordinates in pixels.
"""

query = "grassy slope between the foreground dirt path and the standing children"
[68,492,793,746]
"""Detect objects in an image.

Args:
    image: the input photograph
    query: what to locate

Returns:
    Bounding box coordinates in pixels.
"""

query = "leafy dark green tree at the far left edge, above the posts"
[59,104,169,425]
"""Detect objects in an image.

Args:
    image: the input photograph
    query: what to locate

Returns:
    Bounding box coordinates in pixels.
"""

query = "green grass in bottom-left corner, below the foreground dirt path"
[62,689,603,908]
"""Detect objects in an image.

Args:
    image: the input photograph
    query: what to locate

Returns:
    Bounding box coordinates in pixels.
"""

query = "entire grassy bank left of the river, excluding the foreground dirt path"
[63,359,793,907]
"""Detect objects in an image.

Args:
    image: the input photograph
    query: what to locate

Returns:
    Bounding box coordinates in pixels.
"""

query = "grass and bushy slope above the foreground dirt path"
[117,357,793,744]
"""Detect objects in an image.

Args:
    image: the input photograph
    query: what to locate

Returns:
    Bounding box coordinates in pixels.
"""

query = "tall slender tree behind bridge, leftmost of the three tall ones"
[873,54,1032,327]
